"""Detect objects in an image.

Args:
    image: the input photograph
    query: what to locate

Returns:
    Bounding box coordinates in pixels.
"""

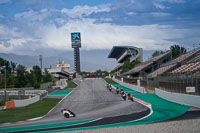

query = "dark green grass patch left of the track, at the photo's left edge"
[0,98,61,123]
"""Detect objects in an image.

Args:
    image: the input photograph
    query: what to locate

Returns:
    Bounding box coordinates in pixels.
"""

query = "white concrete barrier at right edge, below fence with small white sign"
[155,88,200,108]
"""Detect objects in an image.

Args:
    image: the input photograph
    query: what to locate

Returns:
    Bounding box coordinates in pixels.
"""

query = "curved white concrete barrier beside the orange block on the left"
[14,96,40,107]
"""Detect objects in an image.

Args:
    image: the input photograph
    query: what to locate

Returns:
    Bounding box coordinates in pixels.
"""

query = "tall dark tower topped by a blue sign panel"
[71,32,81,73]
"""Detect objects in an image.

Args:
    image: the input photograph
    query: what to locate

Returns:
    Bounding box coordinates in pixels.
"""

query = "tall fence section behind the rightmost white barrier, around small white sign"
[158,75,200,95]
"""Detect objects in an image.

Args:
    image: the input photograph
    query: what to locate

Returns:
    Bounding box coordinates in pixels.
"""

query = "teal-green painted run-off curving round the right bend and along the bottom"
[0,84,190,132]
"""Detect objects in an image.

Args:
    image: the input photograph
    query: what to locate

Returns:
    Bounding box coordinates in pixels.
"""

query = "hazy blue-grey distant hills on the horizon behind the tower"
[0,53,113,72]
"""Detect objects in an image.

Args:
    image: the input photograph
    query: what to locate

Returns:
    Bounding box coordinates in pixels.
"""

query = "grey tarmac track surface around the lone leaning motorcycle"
[0,79,147,131]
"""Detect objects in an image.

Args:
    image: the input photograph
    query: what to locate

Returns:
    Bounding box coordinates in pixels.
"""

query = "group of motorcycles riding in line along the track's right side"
[107,84,134,102]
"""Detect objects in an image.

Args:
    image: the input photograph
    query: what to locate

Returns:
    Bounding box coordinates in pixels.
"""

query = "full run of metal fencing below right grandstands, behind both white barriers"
[116,74,200,96]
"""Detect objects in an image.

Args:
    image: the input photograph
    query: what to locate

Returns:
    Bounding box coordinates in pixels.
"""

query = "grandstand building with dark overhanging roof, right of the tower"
[108,46,143,74]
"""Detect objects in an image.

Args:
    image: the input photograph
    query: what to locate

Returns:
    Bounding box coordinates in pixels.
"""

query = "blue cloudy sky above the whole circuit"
[0,0,200,70]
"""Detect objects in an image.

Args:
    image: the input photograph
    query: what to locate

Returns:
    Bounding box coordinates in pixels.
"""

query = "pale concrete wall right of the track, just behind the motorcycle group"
[112,78,147,93]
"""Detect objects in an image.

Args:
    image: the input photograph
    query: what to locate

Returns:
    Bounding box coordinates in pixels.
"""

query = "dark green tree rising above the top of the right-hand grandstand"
[170,45,187,59]
